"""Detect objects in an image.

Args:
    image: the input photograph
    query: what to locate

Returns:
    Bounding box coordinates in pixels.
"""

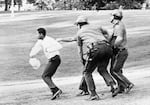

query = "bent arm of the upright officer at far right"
[114,26,124,47]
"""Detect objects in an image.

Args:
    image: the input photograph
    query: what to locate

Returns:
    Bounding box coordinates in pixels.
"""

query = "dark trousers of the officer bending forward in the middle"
[79,44,114,92]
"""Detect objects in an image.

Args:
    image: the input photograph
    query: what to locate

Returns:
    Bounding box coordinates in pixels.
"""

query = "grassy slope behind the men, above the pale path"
[0,11,150,81]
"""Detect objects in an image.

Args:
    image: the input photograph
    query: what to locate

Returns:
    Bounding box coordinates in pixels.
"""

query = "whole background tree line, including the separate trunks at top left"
[2,0,146,11]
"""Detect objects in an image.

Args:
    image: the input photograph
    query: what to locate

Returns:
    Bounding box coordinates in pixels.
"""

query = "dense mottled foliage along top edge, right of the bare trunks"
[53,0,145,10]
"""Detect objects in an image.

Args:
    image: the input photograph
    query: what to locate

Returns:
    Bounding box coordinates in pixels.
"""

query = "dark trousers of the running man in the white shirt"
[42,55,61,89]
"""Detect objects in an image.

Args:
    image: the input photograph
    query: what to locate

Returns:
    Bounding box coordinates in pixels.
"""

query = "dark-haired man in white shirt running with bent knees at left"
[30,28,62,100]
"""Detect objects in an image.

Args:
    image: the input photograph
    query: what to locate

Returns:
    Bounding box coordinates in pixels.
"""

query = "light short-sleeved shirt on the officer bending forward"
[76,25,106,53]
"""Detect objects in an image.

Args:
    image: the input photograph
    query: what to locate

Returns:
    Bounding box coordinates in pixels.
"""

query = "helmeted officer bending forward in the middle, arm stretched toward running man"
[75,16,115,100]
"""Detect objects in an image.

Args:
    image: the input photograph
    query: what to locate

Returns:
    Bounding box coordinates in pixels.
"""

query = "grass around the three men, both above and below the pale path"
[0,10,150,105]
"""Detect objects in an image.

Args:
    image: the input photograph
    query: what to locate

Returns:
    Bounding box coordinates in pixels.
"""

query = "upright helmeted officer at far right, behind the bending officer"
[108,10,134,97]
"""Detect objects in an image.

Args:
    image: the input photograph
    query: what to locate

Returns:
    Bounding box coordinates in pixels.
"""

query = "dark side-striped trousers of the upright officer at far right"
[110,49,131,88]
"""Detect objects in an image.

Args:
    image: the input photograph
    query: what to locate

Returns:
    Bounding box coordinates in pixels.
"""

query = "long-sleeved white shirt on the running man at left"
[30,36,62,59]
